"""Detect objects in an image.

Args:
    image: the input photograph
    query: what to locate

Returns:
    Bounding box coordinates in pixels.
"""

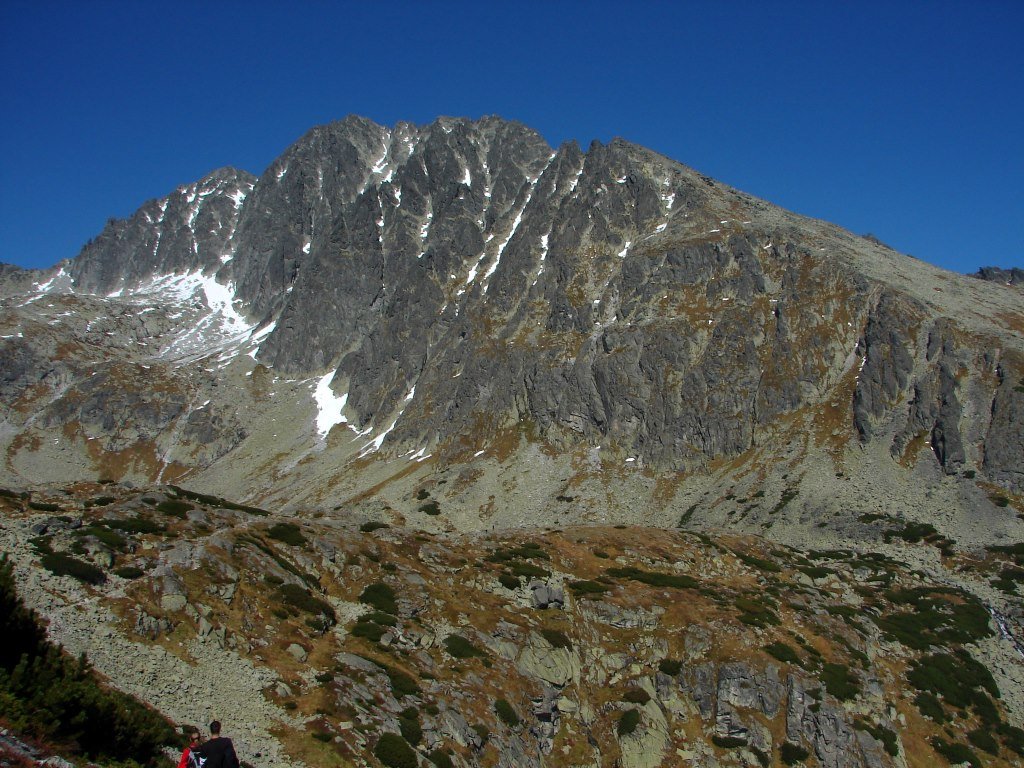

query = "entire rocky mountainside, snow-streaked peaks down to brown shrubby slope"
[0,117,1024,768]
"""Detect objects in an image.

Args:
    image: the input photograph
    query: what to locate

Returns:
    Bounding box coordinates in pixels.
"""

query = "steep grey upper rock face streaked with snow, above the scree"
[0,112,1024,499]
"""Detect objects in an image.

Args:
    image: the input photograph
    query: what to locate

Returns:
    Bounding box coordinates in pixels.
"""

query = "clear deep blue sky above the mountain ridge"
[0,0,1024,271]
